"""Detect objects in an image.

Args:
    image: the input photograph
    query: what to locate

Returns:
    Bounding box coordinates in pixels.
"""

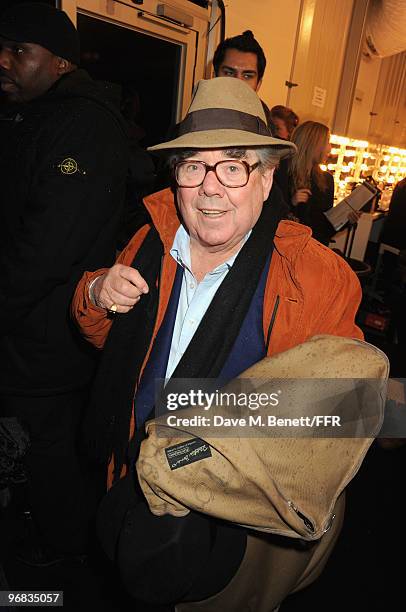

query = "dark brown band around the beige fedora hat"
[178,108,272,137]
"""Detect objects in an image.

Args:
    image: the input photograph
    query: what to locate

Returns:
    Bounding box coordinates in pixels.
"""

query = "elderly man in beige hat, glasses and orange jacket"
[73,77,361,610]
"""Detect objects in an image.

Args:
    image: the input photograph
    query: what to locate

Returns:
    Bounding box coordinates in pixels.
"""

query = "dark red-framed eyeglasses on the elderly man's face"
[175,159,261,187]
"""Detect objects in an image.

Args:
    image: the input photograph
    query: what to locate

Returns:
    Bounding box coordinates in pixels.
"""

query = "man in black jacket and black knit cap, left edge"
[0,3,128,565]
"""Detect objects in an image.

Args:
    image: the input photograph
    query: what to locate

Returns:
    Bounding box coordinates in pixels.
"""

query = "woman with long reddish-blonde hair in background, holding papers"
[289,121,335,246]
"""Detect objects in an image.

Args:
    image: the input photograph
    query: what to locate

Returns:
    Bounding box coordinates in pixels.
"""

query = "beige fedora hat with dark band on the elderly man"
[148,77,296,158]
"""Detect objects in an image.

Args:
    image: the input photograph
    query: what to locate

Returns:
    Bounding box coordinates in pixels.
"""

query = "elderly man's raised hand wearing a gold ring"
[91,264,149,313]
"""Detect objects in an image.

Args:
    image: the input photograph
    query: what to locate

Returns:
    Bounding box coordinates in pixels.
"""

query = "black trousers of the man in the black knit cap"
[0,391,105,554]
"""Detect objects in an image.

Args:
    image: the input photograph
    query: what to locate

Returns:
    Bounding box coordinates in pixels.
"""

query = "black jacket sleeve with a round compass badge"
[0,101,128,335]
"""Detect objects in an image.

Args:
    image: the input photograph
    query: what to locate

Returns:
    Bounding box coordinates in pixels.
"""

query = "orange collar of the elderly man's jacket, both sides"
[144,188,312,263]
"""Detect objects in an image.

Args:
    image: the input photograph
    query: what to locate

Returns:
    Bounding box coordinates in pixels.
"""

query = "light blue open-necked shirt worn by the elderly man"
[166,225,247,379]
